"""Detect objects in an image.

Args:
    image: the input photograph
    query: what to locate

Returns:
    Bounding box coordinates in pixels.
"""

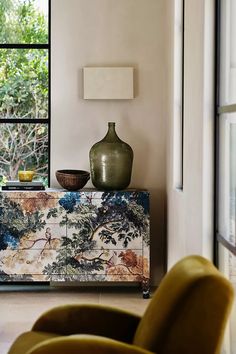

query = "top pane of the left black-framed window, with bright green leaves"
[0,0,48,44]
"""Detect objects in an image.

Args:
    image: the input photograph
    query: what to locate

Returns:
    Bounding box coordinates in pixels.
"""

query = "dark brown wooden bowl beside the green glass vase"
[56,170,90,191]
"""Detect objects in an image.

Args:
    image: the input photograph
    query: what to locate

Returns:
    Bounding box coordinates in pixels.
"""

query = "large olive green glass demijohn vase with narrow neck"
[89,122,133,190]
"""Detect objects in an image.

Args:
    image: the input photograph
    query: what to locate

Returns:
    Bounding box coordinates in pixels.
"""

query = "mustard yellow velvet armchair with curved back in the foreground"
[9,256,234,354]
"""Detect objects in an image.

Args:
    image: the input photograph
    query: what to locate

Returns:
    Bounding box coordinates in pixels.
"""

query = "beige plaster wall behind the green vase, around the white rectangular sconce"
[51,0,168,284]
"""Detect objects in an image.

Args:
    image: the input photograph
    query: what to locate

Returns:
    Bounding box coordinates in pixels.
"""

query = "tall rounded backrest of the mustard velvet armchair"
[133,256,234,354]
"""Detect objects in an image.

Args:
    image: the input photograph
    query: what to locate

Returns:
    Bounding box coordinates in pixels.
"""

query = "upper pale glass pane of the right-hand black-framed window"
[220,0,236,105]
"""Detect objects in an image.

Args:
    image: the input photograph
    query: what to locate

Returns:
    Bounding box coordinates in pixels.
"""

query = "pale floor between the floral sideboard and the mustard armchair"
[0,285,149,354]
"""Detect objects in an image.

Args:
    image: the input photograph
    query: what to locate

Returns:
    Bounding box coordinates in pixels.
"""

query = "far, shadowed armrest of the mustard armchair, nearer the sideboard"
[32,304,141,343]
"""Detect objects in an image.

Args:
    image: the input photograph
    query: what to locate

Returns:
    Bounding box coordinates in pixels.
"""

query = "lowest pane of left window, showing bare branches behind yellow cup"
[0,123,48,181]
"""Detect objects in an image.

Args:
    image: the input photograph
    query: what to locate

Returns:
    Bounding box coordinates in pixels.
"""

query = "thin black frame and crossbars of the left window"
[0,0,51,187]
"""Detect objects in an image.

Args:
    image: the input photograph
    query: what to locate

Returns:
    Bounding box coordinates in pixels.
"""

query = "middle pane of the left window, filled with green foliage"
[0,49,48,118]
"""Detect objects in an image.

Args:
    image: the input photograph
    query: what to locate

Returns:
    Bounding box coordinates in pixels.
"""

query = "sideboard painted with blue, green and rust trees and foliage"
[0,189,150,297]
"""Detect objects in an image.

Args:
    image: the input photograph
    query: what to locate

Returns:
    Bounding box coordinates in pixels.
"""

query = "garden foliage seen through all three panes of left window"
[0,0,48,184]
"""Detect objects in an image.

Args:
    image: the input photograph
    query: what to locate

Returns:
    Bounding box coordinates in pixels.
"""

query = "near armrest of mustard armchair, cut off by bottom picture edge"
[26,335,153,354]
